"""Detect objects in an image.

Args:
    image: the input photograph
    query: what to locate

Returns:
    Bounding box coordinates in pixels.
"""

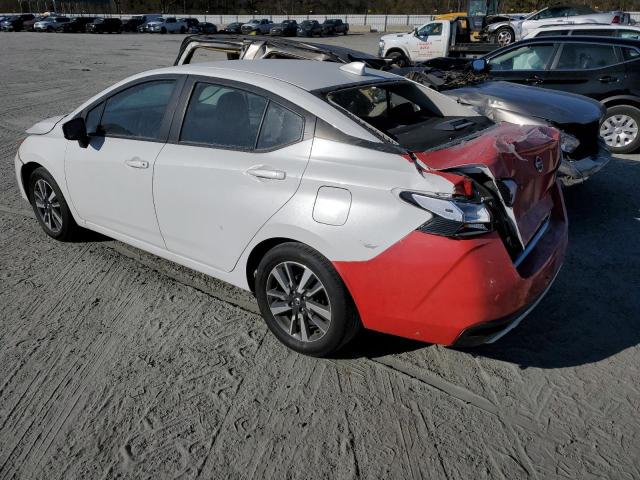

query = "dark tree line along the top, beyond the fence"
[5,0,640,15]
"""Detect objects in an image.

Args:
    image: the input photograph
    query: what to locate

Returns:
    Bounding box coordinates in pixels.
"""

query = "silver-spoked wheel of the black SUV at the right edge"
[600,105,640,153]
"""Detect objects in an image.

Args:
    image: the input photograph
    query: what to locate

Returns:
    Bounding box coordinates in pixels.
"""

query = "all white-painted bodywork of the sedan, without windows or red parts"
[15,60,478,289]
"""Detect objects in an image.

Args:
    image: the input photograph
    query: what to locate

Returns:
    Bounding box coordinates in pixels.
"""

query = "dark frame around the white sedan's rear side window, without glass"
[166,75,316,153]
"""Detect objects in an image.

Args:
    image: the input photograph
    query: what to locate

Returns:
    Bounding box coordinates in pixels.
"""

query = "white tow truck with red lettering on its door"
[378,20,499,66]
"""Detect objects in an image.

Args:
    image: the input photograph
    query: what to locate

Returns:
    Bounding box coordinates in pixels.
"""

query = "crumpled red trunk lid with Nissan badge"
[414,123,560,248]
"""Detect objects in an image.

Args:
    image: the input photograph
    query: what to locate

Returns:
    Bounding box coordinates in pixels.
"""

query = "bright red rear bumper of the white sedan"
[334,184,567,345]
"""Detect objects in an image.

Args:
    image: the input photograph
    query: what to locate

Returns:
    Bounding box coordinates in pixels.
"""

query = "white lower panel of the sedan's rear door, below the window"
[153,139,313,271]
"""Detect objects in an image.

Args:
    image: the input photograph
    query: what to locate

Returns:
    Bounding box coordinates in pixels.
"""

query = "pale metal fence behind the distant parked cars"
[4,12,640,32]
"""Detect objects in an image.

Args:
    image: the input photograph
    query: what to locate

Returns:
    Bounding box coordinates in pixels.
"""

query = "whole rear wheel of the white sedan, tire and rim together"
[255,242,360,357]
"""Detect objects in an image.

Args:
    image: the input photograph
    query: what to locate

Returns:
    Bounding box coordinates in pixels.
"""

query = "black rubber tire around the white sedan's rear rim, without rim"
[255,242,358,356]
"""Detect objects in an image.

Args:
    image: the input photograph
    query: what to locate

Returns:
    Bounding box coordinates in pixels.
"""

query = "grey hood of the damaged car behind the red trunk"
[443,82,604,125]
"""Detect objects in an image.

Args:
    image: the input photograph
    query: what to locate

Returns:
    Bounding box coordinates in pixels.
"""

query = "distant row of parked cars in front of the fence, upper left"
[0,13,349,37]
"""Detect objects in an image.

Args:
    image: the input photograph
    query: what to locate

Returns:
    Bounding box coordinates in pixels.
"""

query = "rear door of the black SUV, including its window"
[544,42,625,100]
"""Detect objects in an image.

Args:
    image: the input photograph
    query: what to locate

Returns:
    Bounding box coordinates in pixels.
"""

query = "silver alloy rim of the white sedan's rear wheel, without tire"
[266,262,332,342]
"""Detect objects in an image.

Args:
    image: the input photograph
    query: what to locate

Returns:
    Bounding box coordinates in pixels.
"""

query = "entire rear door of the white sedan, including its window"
[153,78,315,271]
